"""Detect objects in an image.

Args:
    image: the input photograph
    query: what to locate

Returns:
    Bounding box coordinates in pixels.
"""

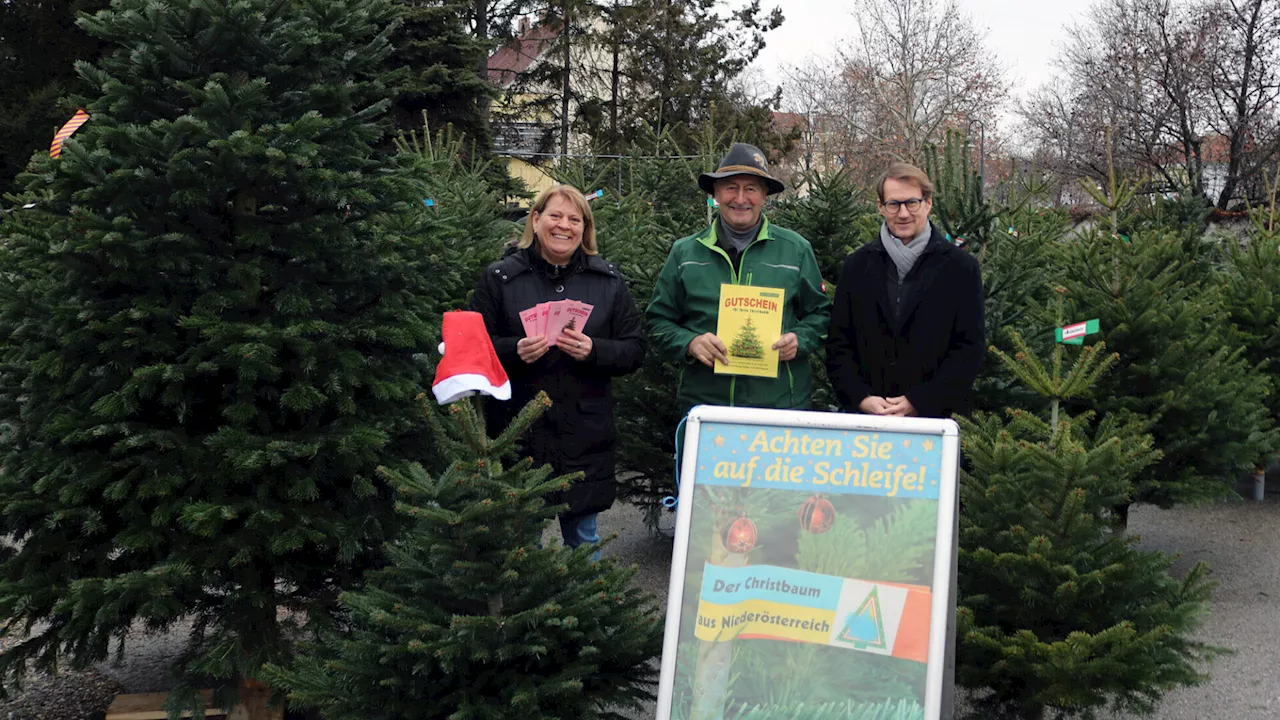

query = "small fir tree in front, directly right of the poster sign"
[956,320,1217,720]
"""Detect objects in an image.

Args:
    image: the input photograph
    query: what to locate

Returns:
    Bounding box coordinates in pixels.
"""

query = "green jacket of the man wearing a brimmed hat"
[645,218,831,413]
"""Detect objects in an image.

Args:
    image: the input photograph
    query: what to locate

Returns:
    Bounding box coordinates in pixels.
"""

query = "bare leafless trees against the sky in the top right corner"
[1019,0,1280,208]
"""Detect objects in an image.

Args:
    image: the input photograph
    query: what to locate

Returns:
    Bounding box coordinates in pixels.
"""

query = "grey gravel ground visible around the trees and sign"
[0,471,1280,720]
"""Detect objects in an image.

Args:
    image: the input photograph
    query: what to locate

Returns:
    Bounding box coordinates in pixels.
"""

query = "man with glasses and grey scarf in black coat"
[827,163,986,418]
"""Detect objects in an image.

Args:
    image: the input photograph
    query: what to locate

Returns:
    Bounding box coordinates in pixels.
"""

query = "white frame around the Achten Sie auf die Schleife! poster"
[657,405,960,720]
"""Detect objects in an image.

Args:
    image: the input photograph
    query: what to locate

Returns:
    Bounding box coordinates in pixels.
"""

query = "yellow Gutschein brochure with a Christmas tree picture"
[716,284,786,378]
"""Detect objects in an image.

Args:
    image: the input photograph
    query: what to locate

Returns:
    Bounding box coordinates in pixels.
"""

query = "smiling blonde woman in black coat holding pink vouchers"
[471,184,646,547]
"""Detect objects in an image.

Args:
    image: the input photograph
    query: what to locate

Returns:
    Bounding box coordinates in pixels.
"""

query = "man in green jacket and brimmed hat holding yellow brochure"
[646,142,831,413]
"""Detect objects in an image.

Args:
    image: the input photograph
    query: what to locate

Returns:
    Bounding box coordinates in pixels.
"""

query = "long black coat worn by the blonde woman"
[471,247,648,516]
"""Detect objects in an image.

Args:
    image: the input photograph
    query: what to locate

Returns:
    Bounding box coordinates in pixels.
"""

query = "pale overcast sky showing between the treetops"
[755,0,1092,112]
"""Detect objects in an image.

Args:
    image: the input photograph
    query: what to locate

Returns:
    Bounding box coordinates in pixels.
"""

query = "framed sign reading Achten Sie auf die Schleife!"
[658,406,959,720]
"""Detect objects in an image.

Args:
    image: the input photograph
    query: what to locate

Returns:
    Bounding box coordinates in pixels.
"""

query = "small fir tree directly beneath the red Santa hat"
[273,395,662,720]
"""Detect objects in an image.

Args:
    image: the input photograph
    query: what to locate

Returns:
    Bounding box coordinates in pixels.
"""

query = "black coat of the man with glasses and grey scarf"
[827,224,987,418]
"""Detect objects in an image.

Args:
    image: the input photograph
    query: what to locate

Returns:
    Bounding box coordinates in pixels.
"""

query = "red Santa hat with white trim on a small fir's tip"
[431,310,511,405]
